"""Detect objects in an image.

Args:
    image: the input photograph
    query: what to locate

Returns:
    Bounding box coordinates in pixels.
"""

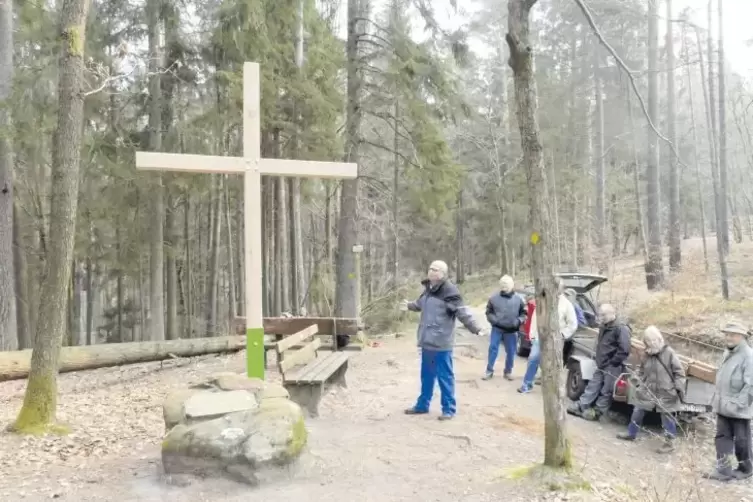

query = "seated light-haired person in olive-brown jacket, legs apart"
[617,326,685,453]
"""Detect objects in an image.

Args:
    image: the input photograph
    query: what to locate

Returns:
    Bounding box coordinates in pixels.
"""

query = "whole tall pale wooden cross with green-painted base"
[136,63,358,378]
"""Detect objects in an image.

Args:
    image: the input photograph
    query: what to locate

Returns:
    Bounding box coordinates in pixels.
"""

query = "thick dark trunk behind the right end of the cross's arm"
[335,0,362,317]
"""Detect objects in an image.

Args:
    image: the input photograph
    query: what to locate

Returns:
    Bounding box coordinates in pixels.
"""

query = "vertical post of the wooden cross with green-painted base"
[243,63,264,379]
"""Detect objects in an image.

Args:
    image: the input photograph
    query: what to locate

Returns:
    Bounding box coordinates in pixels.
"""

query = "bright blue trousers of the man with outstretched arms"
[415,349,457,415]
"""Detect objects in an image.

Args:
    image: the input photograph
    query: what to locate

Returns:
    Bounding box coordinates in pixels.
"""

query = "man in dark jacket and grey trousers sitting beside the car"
[567,304,630,420]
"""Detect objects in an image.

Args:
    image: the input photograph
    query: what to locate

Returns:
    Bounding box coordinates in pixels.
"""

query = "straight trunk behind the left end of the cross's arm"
[147,0,165,341]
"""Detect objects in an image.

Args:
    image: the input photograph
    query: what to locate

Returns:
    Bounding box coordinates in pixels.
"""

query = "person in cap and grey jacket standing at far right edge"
[704,323,753,481]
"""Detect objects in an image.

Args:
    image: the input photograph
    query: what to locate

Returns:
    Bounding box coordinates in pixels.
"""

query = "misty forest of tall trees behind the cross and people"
[0,0,753,432]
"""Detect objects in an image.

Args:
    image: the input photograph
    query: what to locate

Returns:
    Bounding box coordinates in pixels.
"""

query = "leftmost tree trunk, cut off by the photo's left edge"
[0,0,18,350]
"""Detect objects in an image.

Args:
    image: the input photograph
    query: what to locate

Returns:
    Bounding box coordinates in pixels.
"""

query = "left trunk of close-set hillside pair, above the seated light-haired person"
[645,0,664,291]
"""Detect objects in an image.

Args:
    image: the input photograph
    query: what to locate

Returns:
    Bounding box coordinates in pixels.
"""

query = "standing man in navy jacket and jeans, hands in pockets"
[483,275,528,380]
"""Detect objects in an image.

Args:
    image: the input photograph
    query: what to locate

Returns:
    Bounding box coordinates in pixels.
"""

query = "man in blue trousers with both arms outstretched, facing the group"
[401,261,484,420]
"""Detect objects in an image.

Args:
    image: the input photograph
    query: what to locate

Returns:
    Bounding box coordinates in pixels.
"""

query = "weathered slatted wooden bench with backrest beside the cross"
[275,324,348,417]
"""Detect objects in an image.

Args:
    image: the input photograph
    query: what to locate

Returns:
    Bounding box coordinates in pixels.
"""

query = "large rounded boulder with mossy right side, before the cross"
[162,398,308,484]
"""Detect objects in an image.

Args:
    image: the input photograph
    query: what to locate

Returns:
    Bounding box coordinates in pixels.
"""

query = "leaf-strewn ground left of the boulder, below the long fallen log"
[0,354,244,500]
